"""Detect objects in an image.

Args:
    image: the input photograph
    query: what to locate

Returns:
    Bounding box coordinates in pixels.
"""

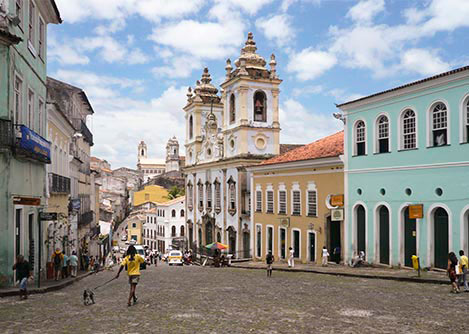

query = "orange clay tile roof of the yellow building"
[261,131,344,165]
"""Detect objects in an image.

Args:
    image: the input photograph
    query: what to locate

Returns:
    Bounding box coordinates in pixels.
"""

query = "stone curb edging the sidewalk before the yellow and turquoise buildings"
[231,264,450,285]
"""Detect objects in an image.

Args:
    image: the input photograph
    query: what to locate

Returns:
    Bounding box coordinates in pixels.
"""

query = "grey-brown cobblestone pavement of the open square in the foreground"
[0,265,469,334]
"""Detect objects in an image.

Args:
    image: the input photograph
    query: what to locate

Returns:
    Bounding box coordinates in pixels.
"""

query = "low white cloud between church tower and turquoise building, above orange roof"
[280,99,343,144]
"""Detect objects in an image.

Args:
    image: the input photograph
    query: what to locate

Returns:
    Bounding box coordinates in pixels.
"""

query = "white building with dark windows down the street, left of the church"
[143,196,186,252]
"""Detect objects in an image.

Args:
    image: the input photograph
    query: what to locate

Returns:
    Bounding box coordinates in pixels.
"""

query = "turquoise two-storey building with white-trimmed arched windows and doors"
[338,66,469,268]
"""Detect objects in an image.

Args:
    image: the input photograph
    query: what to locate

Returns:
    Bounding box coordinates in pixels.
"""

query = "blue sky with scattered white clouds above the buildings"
[48,0,469,169]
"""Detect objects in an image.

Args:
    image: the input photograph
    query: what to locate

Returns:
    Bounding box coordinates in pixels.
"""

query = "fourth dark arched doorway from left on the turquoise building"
[433,207,449,269]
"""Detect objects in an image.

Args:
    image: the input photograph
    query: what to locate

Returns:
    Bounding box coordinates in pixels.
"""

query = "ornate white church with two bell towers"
[184,33,282,257]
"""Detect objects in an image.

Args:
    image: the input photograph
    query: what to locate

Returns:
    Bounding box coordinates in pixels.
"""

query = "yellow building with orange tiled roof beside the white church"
[248,132,344,263]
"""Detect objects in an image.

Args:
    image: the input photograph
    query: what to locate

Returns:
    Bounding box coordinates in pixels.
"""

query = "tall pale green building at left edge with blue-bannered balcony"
[0,0,62,286]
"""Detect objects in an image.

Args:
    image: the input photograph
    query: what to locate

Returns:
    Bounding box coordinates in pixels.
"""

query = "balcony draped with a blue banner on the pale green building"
[13,124,51,164]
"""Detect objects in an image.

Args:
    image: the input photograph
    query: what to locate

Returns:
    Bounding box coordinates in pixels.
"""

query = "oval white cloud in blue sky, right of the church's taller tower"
[287,48,337,81]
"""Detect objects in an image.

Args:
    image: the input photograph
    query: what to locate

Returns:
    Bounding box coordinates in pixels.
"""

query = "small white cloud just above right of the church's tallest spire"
[256,14,295,46]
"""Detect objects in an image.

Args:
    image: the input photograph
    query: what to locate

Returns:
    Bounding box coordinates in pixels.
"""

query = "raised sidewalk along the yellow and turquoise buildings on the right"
[231,261,450,284]
